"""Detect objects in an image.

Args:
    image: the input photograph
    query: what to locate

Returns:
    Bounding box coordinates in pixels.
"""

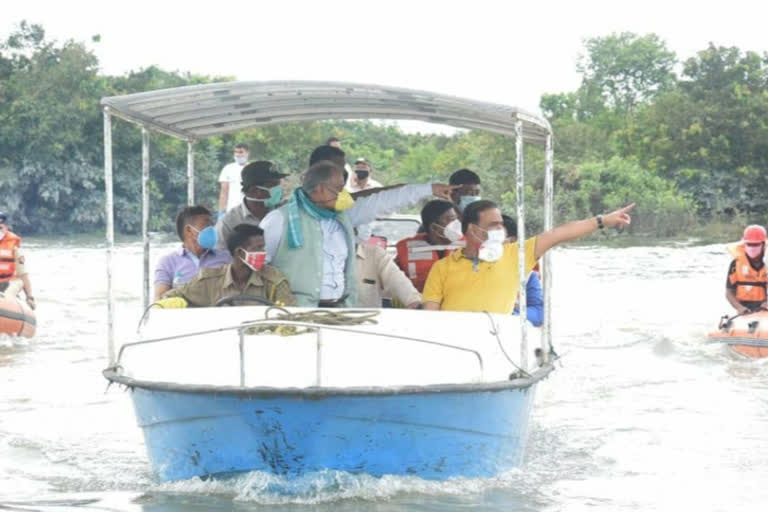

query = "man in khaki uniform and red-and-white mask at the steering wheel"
[157,224,296,308]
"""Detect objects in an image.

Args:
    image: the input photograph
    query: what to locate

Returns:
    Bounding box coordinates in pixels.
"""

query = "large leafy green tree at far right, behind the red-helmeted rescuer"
[631,45,768,220]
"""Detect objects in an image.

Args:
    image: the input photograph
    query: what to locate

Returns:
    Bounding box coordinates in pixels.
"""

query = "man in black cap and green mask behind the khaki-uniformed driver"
[216,160,287,249]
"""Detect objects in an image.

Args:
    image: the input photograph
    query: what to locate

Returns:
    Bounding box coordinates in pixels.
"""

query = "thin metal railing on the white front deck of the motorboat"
[113,318,484,387]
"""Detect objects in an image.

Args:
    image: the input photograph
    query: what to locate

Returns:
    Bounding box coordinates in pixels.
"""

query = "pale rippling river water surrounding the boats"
[0,240,768,512]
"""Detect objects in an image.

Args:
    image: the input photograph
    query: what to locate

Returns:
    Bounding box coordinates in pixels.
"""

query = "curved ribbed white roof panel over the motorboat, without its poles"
[101,81,550,144]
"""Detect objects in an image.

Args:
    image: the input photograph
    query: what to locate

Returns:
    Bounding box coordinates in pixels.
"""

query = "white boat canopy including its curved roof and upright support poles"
[101,81,553,376]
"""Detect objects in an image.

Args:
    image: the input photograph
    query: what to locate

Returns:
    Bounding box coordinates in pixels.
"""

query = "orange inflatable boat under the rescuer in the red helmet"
[709,311,768,358]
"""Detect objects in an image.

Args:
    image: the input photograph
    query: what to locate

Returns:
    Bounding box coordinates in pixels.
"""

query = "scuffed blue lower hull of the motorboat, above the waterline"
[127,382,536,480]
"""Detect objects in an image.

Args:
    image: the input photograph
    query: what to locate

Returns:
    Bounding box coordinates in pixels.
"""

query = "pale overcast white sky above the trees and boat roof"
[0,0,768,118]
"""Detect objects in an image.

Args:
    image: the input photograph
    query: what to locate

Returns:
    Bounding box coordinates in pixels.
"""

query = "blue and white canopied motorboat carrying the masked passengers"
[101,81,553,481]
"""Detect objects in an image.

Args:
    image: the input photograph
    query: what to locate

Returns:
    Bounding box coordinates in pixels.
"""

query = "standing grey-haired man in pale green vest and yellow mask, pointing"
[260,160,452,307]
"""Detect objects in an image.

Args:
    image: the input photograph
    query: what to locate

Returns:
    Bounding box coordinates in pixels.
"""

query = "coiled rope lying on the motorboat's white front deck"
[245,306,379,336]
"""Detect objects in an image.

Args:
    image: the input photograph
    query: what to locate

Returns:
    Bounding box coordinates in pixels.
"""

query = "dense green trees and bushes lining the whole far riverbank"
[0,23,768,236]
